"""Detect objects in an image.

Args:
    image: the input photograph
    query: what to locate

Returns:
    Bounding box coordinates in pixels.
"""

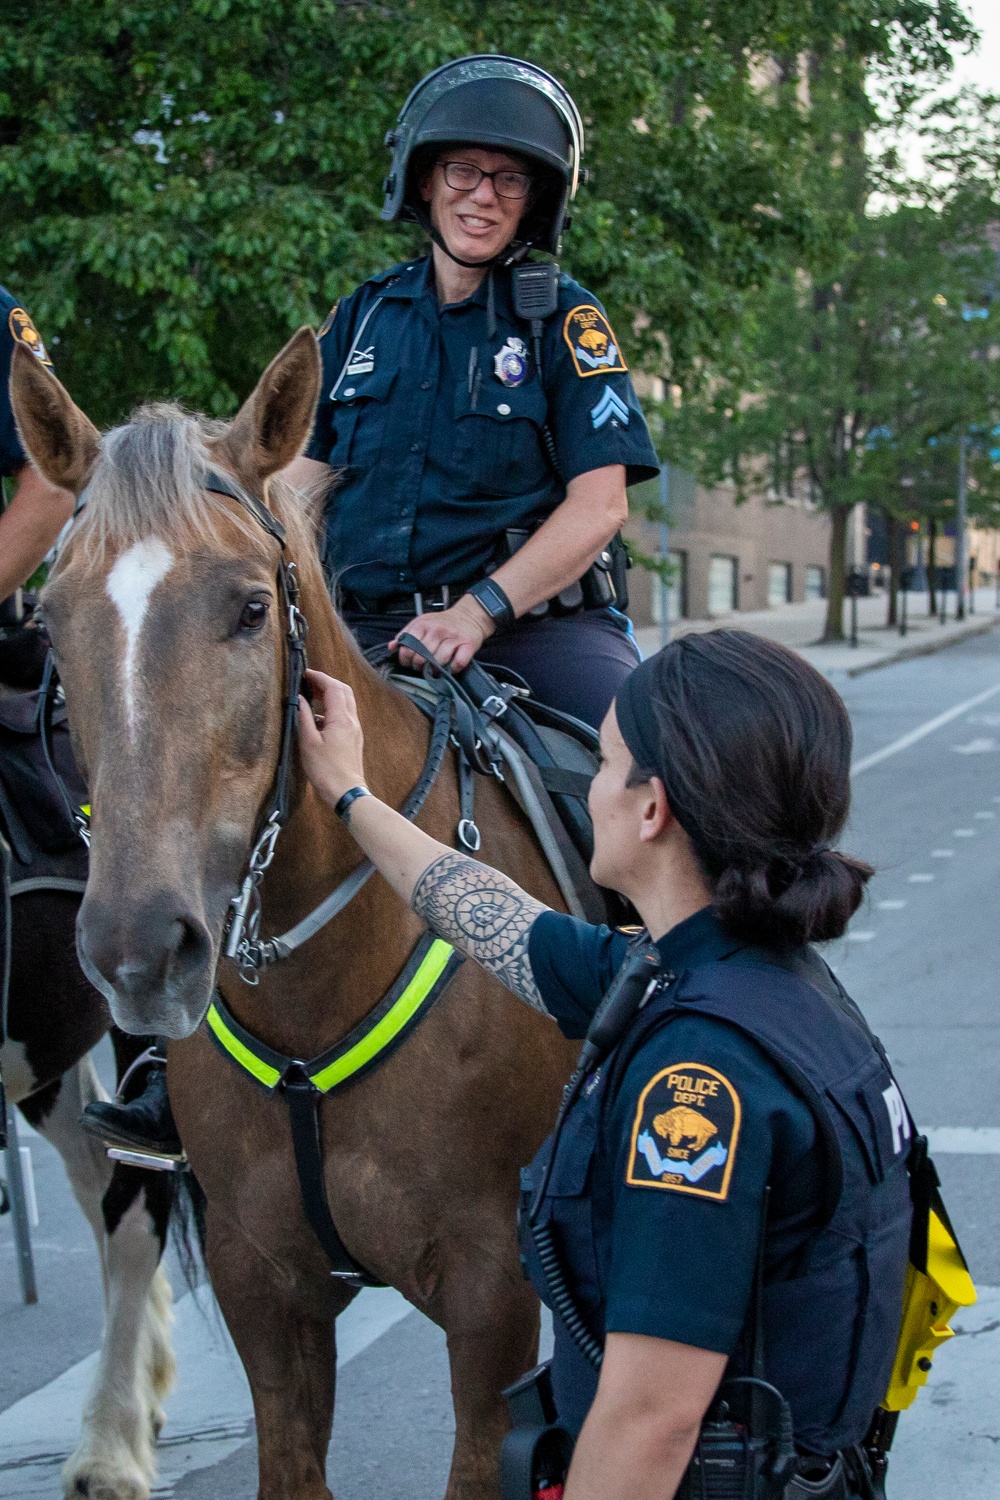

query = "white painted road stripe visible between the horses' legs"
[0,1287,414,1500]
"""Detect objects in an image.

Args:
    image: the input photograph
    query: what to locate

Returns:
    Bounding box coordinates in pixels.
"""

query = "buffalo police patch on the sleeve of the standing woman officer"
[625,1062,742,1200]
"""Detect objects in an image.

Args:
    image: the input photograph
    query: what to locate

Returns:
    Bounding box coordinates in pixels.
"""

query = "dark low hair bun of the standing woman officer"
[715,849,873,948]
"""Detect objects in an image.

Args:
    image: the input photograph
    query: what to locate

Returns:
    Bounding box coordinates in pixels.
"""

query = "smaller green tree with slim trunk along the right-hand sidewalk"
[656,83,1000,639]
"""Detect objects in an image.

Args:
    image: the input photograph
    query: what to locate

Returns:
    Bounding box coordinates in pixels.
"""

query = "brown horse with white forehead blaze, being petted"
[12,330,571,1500]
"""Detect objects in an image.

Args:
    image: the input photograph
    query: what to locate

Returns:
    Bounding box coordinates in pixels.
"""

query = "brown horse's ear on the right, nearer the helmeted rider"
[219,327,321,479]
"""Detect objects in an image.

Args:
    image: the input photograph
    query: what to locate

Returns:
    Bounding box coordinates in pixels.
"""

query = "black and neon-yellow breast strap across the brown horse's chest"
[205,933,463,1287]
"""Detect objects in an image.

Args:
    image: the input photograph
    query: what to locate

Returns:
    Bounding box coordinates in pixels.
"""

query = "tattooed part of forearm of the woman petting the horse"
[412,854,547,1014]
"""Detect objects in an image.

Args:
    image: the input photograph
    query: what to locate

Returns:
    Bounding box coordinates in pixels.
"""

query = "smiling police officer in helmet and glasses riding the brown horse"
[289,56,658,726]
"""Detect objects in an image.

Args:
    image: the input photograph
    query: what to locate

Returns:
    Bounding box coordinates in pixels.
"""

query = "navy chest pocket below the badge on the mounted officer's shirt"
[451,380,552,497]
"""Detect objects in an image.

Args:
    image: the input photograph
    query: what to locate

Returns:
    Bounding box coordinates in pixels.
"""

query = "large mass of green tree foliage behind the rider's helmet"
[0,0,967,423]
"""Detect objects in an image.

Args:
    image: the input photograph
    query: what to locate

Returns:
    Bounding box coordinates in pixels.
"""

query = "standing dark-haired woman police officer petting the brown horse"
[300,630,923,1500]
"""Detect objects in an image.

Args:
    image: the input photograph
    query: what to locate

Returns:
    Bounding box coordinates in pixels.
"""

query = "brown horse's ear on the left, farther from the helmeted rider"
[10,344,100,495]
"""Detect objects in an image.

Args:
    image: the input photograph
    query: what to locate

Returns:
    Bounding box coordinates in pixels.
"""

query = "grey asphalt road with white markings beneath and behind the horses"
[0,630,1000,1500]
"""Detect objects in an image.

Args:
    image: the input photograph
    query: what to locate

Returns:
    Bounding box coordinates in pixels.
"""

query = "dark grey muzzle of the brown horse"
[76,891,214,1038]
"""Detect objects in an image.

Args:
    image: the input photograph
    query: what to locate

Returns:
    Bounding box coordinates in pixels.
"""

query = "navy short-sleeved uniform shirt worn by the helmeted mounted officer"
[306,257,658,597]
